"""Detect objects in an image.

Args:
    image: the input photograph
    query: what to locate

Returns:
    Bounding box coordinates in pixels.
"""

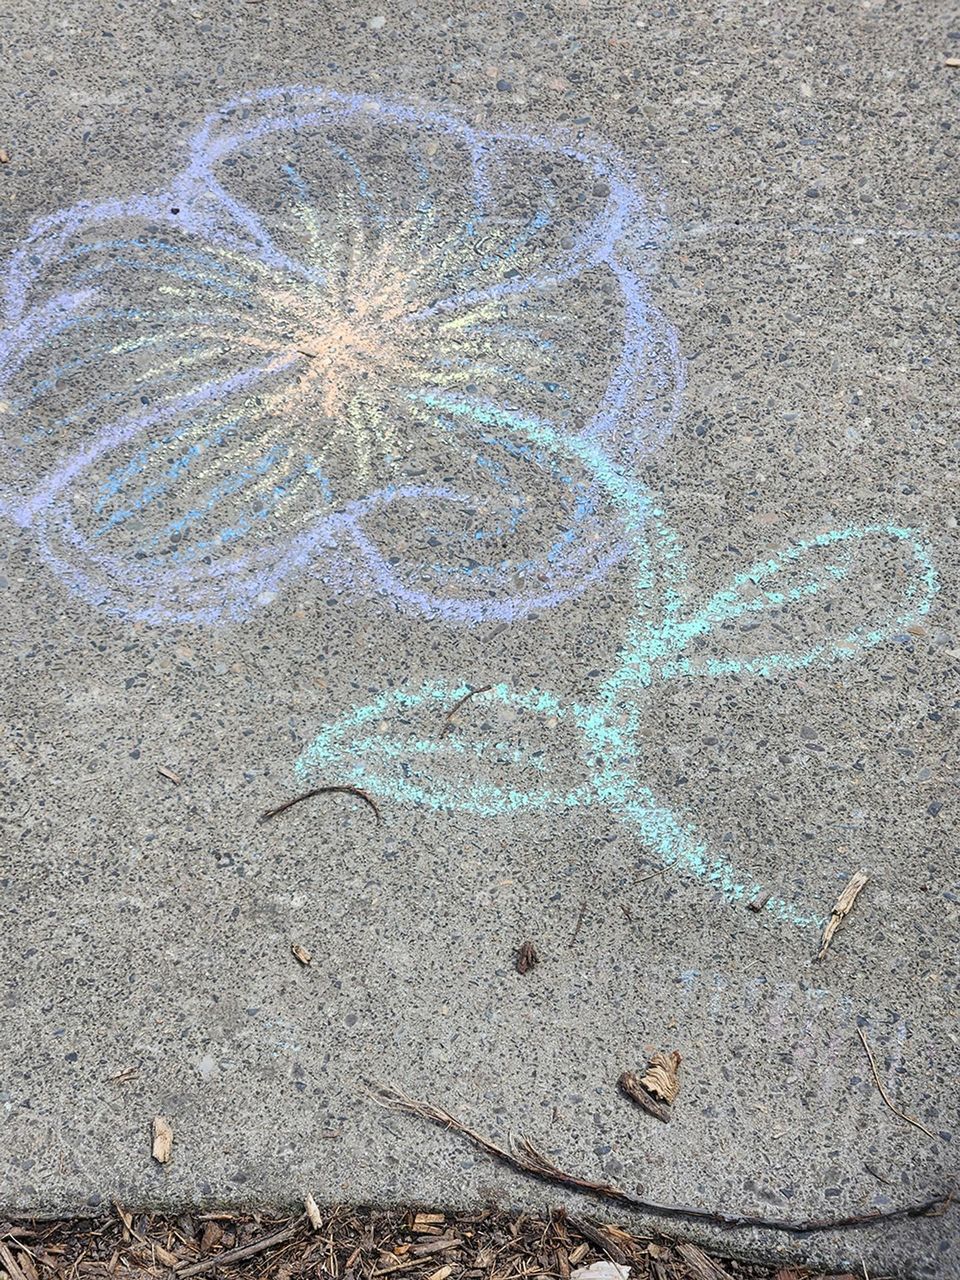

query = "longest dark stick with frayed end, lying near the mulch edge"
[369,1082,952,1235]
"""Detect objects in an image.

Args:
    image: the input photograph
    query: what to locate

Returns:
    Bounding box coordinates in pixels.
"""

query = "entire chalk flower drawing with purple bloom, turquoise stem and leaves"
[0,87,938,924]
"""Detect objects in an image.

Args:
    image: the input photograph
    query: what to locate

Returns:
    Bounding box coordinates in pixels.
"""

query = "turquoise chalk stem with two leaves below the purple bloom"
[294,399,938,927]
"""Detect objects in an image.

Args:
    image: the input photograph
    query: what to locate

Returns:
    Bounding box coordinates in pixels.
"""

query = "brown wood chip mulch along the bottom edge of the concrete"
[0,1206,863,1280]
